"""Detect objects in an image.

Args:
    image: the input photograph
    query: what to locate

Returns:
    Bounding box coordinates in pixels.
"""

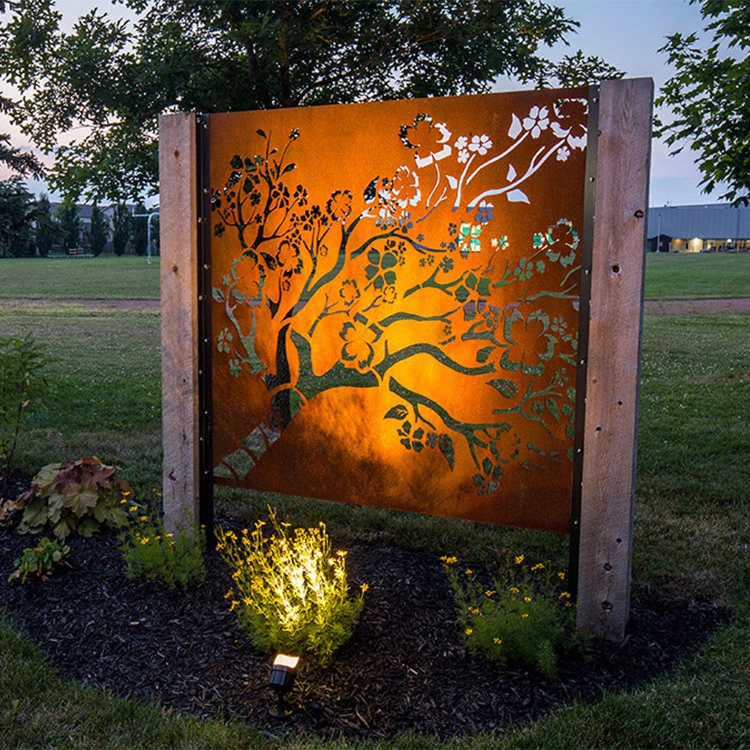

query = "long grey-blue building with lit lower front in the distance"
[646,203,750,253]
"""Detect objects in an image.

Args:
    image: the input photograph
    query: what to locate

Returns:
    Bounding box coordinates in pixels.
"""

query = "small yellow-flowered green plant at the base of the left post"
[120,504,206,590]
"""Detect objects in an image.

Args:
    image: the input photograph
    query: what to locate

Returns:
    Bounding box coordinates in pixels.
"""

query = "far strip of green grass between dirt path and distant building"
[646,253,750,299]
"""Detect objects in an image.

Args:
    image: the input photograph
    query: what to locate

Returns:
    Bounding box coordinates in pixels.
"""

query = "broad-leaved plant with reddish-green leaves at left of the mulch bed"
[18,458,132,539]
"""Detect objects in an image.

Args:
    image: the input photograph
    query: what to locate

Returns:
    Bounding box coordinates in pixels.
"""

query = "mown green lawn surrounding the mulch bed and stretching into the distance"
[0,255,750,748]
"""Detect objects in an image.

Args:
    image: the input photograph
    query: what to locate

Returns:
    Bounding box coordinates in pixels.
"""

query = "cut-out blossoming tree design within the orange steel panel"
[212,99,586,494]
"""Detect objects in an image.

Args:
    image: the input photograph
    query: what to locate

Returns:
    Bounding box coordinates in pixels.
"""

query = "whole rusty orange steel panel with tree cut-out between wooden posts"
[210,89,588,532]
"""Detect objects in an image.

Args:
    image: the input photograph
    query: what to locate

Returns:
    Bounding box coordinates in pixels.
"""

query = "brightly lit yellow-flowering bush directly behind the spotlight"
[216,510,367,663]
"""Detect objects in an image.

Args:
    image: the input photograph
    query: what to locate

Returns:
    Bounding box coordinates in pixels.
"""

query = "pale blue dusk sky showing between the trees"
[0,0,719,206]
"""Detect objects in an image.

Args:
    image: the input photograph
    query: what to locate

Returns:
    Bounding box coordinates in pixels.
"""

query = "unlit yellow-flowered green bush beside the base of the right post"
[441,555,581,677]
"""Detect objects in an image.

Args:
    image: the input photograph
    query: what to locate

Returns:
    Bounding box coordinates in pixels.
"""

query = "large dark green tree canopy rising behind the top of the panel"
[0,0,620,200]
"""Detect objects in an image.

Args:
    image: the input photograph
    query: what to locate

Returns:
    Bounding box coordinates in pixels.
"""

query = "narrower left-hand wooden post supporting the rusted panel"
[159,114,200,530]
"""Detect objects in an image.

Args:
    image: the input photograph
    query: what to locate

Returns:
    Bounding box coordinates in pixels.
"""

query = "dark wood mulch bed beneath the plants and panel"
[0,482,729,739]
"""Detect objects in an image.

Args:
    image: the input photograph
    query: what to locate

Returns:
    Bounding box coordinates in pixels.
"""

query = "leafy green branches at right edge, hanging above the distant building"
[656,0,750,205]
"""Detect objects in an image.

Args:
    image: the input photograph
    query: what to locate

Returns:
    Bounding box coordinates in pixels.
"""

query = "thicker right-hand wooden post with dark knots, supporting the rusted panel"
[577,78,653,641]
